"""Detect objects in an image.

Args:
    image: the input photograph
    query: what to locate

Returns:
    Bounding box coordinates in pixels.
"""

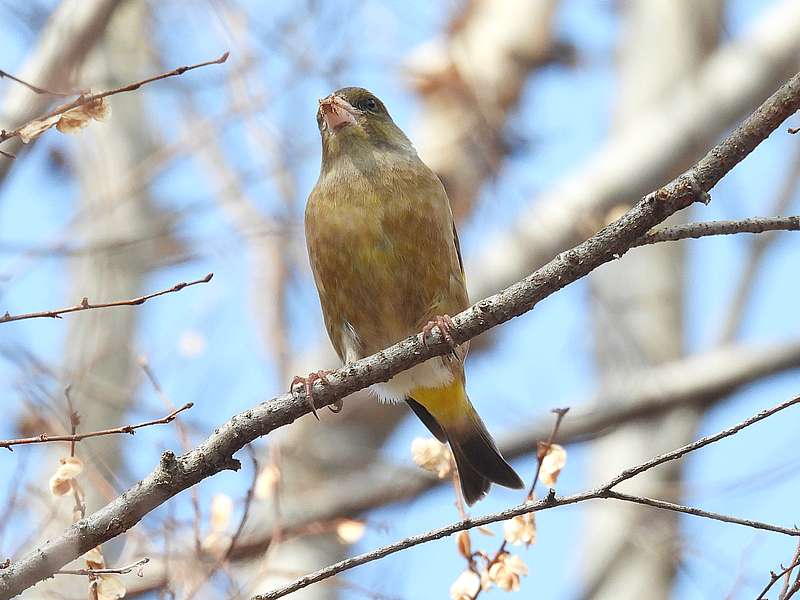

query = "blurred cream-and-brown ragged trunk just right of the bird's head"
[408,0,572,221]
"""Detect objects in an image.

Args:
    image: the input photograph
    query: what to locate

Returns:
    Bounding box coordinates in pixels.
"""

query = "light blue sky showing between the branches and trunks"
[0,0,800,600]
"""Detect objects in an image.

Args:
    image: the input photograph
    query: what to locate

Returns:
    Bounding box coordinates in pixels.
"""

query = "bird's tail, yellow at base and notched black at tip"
[409,378,524,505]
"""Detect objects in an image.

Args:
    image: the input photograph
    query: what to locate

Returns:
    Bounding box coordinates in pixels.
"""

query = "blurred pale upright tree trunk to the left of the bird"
[37,2,174,597]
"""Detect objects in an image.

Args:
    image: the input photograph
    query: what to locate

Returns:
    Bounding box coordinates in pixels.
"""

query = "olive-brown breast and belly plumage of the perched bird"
[306,159,465,356]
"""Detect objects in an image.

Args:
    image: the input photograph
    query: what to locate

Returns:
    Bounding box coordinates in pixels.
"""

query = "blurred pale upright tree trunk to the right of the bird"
[585,0,724,600]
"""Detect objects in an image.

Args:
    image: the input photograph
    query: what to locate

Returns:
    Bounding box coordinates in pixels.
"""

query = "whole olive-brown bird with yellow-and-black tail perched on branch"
[295,87,523,504]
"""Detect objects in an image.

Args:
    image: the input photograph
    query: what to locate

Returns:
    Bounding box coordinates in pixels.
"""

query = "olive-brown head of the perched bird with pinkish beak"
[317,87,413,165]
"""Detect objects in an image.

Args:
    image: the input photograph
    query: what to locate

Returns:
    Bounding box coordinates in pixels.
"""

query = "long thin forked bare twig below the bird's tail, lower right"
[251,396,800,600]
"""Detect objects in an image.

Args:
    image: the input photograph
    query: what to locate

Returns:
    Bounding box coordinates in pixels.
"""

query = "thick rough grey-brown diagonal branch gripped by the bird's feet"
[0,74,800,598]
